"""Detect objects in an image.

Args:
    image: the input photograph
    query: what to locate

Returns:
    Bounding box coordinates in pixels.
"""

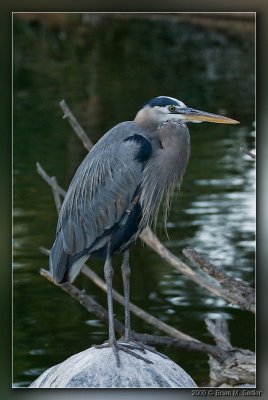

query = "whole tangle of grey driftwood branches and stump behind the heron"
[37,100,256,387]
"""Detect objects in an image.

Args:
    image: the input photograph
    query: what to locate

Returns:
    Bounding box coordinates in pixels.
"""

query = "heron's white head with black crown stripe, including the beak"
[135,96,239,126]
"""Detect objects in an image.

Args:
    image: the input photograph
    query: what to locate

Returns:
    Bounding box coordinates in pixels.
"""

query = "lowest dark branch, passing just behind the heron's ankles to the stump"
[40,268,228,360]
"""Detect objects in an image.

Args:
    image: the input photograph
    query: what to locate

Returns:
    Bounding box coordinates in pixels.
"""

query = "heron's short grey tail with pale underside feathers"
[49,231,89,283]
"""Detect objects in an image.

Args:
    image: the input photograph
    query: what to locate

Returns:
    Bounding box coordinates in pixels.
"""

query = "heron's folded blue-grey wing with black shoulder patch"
[57,122,151,254]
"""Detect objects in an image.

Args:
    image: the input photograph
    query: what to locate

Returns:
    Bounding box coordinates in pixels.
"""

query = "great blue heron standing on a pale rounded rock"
[50,96,238,365]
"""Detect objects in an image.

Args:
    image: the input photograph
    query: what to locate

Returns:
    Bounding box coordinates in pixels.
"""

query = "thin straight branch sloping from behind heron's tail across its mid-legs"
[39,247,198,342]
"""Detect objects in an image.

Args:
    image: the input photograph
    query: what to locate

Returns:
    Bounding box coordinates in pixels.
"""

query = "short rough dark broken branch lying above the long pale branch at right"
[182,247,255,305]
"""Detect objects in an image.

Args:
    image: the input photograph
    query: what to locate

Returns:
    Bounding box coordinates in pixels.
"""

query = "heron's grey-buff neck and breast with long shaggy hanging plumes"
[140,121,190,226]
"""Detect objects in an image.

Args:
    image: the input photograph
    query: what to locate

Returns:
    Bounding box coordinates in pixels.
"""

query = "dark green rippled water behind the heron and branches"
[13,16,255,386]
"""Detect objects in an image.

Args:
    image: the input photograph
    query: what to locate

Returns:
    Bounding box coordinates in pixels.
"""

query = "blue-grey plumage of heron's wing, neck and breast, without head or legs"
[51,118,189,282]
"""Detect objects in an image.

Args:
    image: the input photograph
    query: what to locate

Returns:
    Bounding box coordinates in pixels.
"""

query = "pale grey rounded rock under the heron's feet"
[30,347,197,388]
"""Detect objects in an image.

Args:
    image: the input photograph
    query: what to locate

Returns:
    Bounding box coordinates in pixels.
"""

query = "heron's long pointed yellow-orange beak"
[179,107,240,124]
